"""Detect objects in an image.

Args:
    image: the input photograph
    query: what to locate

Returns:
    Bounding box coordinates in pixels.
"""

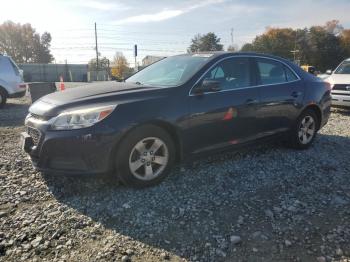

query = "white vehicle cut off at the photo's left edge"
[0,54,27,108]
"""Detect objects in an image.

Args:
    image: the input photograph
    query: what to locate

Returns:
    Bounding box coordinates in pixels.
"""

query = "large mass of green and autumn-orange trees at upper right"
[241,20,350,71]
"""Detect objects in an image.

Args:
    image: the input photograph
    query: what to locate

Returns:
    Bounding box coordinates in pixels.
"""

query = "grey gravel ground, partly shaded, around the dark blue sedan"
[0,99,350,262]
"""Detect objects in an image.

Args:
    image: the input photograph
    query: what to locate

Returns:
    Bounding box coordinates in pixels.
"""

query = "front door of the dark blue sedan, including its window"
[188,57,259,152]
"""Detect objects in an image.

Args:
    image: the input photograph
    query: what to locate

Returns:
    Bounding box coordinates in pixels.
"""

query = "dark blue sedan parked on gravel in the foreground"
[21,52,331,187]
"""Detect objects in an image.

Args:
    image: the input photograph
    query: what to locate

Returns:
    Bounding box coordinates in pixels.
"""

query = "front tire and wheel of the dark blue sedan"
[115,125,175,188]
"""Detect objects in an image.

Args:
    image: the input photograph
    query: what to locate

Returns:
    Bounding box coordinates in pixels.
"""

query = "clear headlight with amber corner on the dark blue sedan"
[51,105,116,130]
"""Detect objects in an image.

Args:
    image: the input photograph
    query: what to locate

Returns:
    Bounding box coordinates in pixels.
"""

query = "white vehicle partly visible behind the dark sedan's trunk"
[325,58,350,107]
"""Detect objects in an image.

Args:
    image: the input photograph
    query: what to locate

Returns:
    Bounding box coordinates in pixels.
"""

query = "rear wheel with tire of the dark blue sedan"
[288,109,319,150]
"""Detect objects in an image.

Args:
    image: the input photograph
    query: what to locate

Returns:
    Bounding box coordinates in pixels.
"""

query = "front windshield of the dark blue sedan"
[125,54,211,87]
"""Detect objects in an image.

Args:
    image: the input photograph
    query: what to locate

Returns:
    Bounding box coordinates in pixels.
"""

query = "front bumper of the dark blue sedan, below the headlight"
[21,116,120,175]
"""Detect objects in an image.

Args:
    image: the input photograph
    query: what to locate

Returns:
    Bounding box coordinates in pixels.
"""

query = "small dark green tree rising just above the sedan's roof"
[187,32,223,53]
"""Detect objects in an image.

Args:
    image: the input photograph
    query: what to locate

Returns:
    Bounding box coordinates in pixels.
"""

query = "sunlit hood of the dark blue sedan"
[29,82,166,117]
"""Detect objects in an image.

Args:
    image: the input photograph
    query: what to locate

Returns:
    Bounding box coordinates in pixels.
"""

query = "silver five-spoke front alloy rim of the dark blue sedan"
[129,137,169,181]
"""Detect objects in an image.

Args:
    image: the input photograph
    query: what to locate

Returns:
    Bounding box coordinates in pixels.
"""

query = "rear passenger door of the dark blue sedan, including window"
[255,58,304,135]
